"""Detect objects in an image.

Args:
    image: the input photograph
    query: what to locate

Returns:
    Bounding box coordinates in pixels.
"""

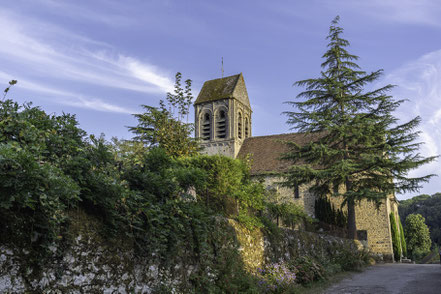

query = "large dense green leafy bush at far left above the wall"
[0,100,84,253]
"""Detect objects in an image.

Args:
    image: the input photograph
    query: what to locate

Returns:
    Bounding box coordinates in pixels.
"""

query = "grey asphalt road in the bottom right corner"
[324,263,441,294]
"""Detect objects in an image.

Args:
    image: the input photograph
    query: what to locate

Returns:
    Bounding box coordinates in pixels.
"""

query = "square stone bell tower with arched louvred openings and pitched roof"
[194,73,252,158]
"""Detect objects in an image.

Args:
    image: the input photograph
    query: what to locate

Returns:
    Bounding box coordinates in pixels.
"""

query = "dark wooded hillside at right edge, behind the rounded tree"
[399,193,441,245]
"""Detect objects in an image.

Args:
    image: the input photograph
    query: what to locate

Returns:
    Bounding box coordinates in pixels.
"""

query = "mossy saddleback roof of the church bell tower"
[194,73,250,106]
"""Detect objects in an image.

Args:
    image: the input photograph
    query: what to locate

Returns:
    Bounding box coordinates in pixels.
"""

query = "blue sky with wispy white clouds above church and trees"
[0,0,441,199]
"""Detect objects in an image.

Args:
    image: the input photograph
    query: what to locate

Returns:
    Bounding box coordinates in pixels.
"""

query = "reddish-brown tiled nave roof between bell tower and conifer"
[237,133,318,175]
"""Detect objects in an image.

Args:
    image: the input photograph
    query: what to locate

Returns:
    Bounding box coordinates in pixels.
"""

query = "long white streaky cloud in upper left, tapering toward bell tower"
[0,9,173,93]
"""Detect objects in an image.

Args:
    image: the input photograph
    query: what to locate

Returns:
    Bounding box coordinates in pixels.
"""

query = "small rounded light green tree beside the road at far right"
[404,214,432,259]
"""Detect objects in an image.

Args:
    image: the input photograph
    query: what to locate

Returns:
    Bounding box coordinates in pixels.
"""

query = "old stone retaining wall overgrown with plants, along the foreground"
[0,213,359,294]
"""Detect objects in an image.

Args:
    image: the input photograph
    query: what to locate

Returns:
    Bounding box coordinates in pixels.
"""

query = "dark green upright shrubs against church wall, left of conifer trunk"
[314,197,348,228]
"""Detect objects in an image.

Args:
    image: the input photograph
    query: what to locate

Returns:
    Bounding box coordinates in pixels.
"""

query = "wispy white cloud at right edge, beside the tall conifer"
[386,50,441,198]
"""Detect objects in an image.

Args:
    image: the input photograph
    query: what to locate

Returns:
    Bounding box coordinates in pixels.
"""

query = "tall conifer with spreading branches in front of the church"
[283,16,435,238]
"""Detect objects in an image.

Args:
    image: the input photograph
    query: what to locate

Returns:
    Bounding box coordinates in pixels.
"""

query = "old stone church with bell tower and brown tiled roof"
[194,73,399,261]
